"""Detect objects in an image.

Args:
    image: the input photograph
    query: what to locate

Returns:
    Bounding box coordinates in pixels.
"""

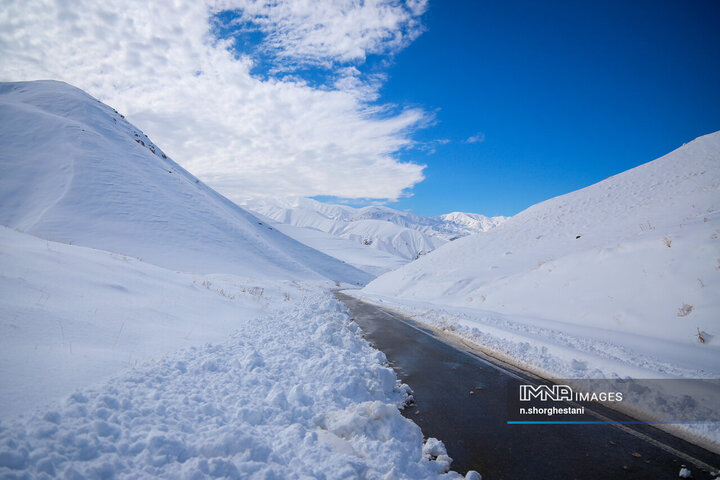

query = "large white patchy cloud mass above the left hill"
[0,0,427,200]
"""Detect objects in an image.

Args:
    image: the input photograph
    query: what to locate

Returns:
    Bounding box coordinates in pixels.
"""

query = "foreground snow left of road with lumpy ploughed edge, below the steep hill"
[0,227,466,479]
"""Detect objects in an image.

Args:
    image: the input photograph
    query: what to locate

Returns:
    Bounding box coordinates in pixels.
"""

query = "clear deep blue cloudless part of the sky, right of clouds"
[324,0,720,215]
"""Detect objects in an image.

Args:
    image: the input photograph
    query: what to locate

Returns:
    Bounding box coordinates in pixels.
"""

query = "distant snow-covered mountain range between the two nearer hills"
[245,198,505,273]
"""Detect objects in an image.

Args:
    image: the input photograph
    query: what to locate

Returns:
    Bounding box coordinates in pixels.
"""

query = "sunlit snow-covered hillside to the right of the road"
[359,132,720,378]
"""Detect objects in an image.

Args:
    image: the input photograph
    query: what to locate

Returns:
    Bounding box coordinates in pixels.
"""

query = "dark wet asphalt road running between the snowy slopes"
[336,292,720,480]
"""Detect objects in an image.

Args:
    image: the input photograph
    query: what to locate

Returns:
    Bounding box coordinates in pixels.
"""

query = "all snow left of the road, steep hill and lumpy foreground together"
[0,81,459,479]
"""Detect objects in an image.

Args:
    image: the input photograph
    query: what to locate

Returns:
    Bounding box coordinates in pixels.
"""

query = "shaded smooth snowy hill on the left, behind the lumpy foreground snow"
[0,81,371,284]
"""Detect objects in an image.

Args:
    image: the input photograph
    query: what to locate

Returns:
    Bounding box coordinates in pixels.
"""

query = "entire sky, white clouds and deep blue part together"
[5,0,720,215]
